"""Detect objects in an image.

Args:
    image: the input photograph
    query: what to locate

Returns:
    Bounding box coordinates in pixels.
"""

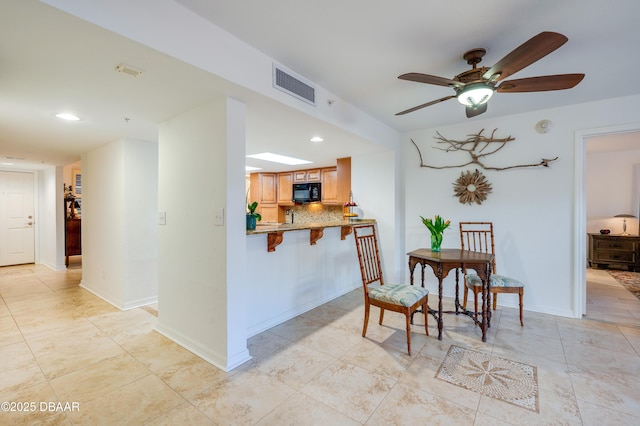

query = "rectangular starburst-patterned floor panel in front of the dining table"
[436,345,539,413]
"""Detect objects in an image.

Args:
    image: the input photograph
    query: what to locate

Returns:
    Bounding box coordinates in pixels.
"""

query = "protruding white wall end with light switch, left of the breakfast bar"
[156,97,250,370]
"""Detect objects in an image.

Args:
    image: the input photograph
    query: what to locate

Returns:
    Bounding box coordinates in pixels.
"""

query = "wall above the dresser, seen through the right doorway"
[586,146,640,234]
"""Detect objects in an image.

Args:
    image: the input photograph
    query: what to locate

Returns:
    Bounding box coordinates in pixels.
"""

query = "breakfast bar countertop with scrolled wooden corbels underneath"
[247,219,376,252]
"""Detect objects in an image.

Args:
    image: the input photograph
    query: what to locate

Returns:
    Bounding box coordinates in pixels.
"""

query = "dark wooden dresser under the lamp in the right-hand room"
[589,234,640,271]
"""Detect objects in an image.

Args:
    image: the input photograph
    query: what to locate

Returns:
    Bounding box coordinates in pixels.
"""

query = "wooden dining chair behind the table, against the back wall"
[460,222,524,326]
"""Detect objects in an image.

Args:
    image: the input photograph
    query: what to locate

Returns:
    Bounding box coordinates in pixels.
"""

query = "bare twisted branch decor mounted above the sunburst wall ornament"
[411,129,558,170]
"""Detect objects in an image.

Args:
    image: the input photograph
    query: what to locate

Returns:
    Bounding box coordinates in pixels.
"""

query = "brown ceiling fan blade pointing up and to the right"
[482,31,568,81]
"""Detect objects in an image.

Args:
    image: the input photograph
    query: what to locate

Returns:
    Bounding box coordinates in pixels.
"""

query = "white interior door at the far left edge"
[0,172,35,266]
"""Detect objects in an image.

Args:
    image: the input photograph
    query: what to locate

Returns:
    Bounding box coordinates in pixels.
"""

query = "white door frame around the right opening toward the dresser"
[573,123,640,318]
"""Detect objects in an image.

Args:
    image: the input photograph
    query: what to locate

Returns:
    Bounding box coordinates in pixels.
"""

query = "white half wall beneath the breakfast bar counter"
[246,227,362,336]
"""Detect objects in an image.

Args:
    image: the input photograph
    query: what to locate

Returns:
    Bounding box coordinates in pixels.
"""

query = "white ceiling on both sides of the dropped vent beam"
[0,0,640,171]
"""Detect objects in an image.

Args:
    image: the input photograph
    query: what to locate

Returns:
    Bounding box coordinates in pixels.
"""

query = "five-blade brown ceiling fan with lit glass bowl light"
[396,31,584,118]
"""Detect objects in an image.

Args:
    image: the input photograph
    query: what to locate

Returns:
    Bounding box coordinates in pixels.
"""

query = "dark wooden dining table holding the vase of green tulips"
[407,248,494,342]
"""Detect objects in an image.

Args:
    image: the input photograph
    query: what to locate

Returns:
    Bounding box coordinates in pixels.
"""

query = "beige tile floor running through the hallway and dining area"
[0,265,640,425]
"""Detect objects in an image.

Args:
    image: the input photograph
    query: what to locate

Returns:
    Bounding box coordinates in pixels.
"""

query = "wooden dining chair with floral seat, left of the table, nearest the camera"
[353,224,429,356]
